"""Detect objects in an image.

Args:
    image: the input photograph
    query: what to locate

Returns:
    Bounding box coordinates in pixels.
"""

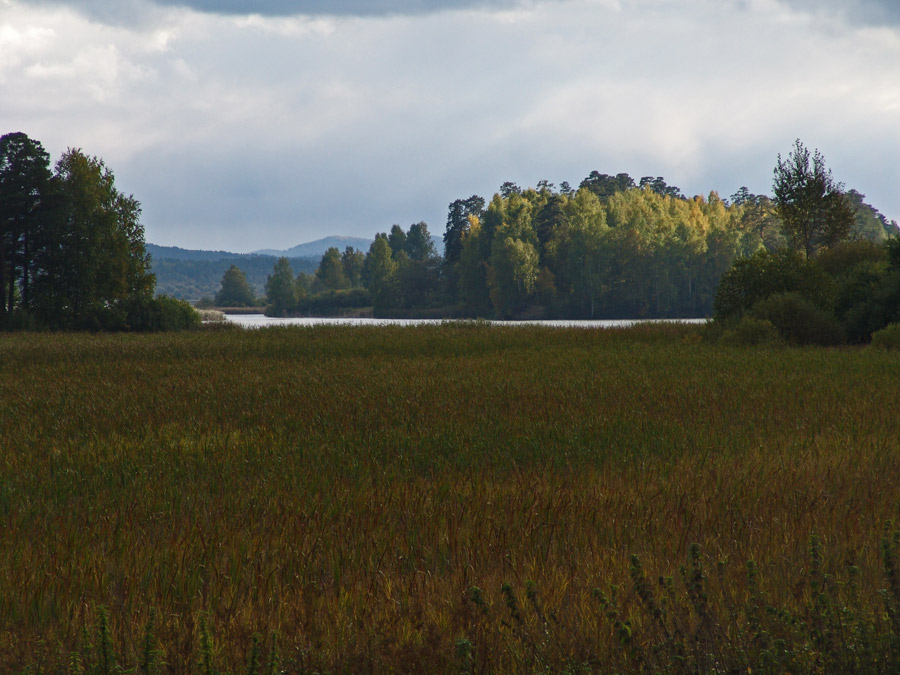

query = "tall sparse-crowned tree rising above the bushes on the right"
[773,139,854,258]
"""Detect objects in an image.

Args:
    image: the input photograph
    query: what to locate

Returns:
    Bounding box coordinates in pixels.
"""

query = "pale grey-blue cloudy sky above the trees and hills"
[0,0,900,251]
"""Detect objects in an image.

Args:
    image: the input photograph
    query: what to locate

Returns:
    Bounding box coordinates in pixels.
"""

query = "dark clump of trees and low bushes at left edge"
[0,132,197,330]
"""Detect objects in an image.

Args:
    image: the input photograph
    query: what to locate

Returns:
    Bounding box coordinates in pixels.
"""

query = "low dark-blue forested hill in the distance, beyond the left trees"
[147,244,322,302]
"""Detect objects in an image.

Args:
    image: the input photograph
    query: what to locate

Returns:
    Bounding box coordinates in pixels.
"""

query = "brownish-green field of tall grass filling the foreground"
[0,324,900,673]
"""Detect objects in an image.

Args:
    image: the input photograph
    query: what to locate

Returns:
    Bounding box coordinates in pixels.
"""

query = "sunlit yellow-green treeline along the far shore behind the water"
[256,171,896,319]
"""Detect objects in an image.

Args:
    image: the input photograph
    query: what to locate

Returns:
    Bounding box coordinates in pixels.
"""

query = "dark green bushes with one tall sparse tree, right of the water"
[708,140,900,347]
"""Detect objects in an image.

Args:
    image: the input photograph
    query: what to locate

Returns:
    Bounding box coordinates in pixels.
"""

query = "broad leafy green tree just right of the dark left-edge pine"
[32,149,155,329]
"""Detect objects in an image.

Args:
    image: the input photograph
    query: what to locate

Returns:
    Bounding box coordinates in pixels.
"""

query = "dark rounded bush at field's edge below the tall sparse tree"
[750,292,846,346]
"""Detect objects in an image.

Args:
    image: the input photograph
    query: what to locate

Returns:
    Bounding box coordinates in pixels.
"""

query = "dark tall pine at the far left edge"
[0,132,52,317]
